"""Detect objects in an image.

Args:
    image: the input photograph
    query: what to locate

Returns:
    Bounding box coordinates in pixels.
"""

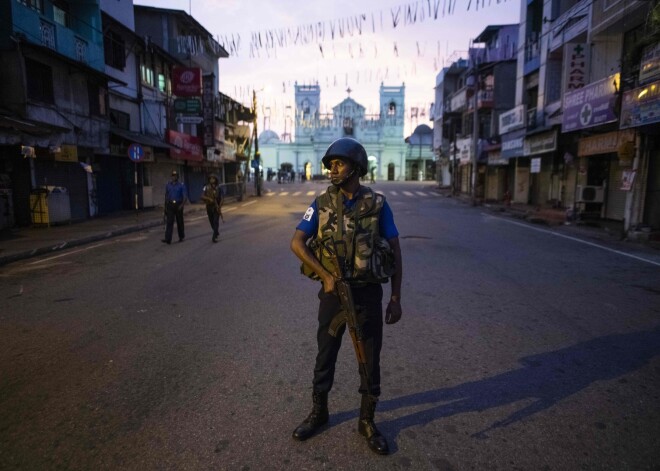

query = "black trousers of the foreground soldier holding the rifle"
[313,284,383,396]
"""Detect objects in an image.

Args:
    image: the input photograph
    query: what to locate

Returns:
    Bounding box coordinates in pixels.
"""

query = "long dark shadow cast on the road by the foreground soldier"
[332,327,660,446]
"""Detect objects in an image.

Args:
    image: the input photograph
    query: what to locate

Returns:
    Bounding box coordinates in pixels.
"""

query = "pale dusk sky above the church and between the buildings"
[135,0,520,134]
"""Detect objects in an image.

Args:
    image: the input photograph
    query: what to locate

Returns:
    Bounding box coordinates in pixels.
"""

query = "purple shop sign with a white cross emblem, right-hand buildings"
[562,73,619,132]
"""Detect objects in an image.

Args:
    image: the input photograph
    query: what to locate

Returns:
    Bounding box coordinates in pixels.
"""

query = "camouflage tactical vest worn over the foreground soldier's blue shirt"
[301,186,395,285]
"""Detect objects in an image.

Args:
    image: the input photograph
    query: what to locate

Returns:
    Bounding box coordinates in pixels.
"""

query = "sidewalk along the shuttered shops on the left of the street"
[0,203,205,266]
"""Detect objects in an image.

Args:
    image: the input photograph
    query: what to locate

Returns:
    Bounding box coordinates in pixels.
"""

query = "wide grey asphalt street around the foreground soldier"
[0,182,660,471]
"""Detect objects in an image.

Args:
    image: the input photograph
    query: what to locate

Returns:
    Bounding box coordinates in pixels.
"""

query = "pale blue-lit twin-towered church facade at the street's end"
[259,83,408,180]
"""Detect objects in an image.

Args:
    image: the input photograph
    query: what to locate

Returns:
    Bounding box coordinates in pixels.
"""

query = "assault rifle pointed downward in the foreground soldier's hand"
[321,236,371,394]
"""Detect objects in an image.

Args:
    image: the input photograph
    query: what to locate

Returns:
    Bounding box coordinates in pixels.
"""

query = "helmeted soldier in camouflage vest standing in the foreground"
[291,138,402,454]
